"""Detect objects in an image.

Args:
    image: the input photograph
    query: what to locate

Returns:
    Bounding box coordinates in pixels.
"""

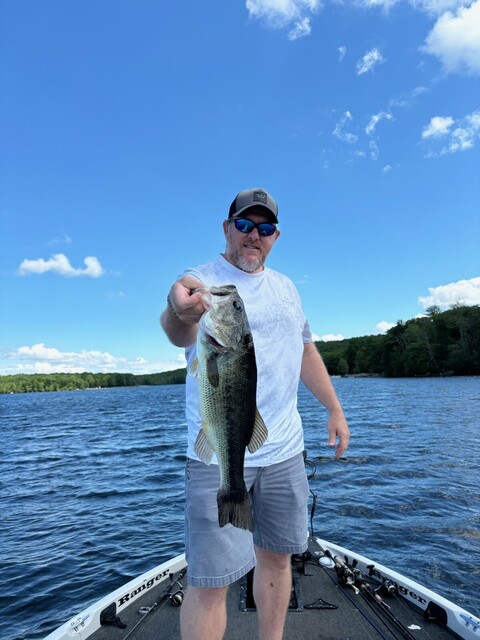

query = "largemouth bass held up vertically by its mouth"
[190,284,268,531]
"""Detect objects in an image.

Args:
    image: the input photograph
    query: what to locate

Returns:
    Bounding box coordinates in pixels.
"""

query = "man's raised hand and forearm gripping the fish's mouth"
[160,276,206,347]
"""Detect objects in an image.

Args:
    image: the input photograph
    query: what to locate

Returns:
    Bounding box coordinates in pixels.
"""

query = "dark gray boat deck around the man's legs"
[88,542,454,640]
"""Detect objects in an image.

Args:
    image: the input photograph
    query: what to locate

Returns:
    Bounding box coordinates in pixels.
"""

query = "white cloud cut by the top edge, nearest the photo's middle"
[246,0,321,35]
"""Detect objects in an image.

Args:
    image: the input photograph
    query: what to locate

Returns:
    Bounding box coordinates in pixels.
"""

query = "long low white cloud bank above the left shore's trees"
[0,343,186,375]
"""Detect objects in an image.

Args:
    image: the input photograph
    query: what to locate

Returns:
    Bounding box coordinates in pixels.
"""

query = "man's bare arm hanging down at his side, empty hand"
[300,342,350,460]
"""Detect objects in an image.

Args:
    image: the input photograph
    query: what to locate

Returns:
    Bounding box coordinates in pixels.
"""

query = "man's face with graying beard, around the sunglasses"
[223,209,280,273]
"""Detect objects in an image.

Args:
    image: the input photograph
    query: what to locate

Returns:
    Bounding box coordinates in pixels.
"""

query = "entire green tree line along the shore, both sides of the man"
[0,305,480,393]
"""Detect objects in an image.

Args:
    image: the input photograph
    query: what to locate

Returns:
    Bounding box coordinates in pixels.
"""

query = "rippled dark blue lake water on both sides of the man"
[0,378,480,640]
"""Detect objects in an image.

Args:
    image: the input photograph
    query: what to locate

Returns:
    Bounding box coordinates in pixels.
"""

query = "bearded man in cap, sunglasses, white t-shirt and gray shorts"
[161,189,350,640]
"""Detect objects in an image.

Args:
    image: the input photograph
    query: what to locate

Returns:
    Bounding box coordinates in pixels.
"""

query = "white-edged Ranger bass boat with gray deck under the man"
[45,534,480,640]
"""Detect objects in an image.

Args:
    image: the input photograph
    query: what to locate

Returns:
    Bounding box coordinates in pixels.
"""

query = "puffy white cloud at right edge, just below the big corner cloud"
[422,110,480,157]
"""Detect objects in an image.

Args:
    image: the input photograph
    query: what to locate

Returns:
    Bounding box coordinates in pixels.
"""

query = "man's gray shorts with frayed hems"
[185,453,309,587]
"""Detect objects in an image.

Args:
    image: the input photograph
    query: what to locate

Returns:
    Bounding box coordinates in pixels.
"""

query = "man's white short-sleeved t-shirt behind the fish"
[184,255,312,467]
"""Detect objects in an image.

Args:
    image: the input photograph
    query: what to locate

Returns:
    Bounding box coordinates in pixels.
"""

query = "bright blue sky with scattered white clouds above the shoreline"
[0,0,480,374]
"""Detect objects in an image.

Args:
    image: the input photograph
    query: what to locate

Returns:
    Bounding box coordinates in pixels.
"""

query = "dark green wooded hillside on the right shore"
[316,305,480,377]
